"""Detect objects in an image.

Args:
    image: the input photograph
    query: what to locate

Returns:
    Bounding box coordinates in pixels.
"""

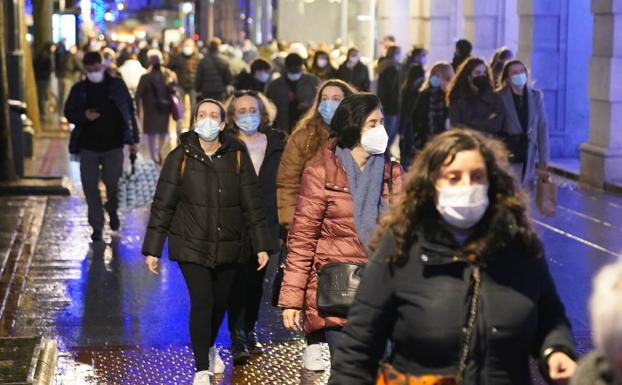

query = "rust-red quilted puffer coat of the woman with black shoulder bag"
[279,139,402,335]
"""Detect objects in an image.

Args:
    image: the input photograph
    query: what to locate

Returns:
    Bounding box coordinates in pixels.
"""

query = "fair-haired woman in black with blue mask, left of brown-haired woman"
[412,62,454,151]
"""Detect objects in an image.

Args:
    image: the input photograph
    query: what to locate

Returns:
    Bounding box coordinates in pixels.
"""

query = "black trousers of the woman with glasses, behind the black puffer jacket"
[227,255,267,331]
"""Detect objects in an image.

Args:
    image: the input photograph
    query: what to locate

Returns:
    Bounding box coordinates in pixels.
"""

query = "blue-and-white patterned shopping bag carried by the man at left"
[117,155,160,211]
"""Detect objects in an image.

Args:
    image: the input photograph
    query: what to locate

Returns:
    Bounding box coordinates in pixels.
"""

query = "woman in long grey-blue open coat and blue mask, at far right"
[498,60,550,189]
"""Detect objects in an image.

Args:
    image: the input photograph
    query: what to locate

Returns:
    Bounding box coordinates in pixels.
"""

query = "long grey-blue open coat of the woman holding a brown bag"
[498,86,550,186]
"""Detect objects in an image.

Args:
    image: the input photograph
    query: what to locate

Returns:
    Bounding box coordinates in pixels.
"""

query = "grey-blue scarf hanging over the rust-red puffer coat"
[335,147,384,247]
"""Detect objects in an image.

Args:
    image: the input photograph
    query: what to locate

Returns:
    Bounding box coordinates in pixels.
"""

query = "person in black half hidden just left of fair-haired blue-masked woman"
[398,64,425,168]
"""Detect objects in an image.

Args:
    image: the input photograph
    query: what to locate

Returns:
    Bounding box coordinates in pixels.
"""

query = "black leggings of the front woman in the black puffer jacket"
[179,263,237,371]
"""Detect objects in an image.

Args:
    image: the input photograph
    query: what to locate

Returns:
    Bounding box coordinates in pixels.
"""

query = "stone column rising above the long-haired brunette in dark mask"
[464,0,505,62]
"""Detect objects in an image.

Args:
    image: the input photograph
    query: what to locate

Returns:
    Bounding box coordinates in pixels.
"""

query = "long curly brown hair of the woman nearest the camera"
[371,129,542,264]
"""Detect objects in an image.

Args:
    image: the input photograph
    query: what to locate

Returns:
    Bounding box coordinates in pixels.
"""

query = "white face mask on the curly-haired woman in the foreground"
[436,184,489,230]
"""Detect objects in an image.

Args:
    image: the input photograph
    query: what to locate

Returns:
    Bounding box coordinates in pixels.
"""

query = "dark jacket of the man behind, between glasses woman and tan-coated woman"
[266,73,319,132]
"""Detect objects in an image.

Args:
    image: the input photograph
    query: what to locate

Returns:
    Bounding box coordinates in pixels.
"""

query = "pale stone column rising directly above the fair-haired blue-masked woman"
[411,0,464,64]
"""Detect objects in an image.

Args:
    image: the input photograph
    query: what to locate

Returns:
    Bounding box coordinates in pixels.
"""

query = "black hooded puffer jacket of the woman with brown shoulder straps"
[142,131,273,268]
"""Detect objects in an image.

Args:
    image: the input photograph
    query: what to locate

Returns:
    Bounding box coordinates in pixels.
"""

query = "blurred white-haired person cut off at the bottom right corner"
[570,261,622,385]
